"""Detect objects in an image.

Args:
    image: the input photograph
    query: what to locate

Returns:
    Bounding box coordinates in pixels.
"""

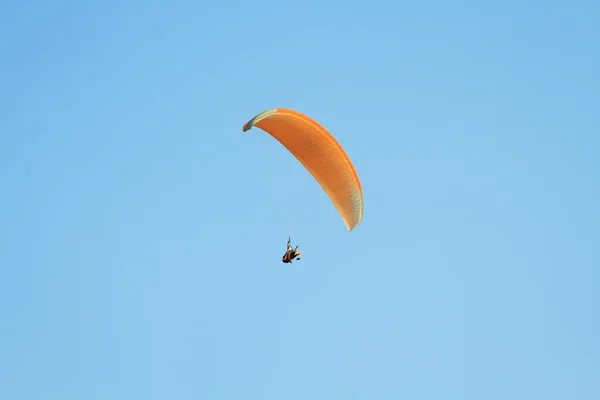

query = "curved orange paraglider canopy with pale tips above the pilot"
[242,108,364,231]
